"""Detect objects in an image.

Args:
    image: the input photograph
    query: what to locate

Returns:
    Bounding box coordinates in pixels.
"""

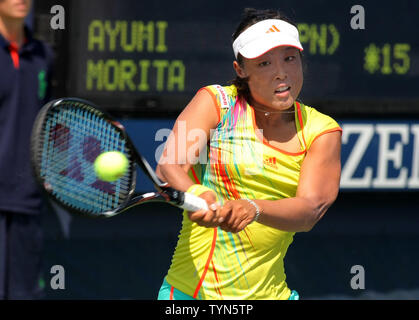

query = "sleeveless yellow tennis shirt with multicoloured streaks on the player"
[166,85,341,300]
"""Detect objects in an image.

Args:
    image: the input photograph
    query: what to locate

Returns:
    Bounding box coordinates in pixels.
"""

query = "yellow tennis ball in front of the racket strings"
[94,151,128,182]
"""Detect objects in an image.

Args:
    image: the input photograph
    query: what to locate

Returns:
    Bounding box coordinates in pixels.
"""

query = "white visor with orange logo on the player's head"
[233,19,303,59]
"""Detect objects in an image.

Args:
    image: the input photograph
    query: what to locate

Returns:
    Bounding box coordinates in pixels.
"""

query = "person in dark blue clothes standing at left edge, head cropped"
[0,0,53,299]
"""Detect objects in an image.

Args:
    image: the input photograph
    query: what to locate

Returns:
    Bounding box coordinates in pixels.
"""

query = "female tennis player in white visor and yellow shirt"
[157,9,341,300]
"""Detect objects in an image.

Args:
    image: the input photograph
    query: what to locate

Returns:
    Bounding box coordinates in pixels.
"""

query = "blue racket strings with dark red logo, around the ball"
[40,105,131,213]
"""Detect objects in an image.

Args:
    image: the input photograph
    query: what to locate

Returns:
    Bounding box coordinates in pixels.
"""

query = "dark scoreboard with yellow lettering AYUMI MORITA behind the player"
[37,0,419,116]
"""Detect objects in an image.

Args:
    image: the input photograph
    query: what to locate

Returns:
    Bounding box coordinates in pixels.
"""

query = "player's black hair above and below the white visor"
[231,8,302,101]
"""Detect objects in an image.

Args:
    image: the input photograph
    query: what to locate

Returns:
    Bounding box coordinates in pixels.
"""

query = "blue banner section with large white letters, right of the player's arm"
[341,120,419,190]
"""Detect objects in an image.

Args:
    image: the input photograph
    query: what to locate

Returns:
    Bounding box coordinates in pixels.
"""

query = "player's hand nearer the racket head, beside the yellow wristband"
[188,191,220,228]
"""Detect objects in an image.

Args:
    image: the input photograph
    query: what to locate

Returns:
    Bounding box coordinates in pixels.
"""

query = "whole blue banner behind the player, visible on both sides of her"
[121,119,419,191]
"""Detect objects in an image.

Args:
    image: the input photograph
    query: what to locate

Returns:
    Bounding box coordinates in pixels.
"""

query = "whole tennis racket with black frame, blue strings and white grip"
[31,98,208,217]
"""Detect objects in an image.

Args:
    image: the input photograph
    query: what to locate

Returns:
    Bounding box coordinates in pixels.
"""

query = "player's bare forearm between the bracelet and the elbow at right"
[255,197,333,232]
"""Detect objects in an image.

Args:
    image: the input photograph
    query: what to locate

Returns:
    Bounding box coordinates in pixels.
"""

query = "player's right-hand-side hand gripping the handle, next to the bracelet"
[217,200,256,233]
